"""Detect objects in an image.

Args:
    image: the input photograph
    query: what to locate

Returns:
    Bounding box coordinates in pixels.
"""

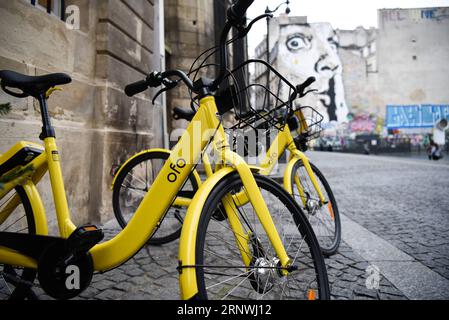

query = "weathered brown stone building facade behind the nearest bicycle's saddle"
[0,0,165,229]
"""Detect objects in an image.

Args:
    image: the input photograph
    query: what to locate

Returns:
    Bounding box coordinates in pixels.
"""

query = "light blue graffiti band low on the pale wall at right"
[386,104,449,129]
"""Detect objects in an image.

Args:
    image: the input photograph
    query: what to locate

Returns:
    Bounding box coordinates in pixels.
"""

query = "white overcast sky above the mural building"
[248,0,449,55]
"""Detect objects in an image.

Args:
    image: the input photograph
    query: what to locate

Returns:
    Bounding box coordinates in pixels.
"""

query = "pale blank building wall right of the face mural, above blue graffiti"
[338,8,449,117]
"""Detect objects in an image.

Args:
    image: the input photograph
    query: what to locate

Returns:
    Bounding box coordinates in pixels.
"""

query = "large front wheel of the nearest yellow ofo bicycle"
[195,174,329,300]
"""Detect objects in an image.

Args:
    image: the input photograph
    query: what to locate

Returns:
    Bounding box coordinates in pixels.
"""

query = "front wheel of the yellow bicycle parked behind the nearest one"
[291,161,341,256]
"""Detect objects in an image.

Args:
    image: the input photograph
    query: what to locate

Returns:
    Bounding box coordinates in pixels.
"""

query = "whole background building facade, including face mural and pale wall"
[257,7,449,131]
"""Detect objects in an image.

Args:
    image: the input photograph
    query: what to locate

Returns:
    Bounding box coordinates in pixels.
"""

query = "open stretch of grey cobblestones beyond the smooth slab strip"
[311,153,449,279]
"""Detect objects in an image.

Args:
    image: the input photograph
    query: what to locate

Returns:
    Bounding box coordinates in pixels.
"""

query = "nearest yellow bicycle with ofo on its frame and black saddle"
[0,0,329,299]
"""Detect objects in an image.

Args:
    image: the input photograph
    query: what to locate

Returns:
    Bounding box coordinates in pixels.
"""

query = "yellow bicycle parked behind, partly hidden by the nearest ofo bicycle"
[111,88,341,256]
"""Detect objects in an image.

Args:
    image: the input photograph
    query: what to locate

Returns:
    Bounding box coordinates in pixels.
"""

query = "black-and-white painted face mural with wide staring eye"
[278,23,348,122]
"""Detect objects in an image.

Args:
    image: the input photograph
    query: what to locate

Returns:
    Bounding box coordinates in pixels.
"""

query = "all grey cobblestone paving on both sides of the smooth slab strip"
[0,153,449,300]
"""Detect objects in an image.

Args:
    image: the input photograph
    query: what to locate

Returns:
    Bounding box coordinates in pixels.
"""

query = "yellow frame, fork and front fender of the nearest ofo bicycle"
[0,97,291,299]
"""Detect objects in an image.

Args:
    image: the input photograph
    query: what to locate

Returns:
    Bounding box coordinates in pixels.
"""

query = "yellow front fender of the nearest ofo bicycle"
[178,167,236,300]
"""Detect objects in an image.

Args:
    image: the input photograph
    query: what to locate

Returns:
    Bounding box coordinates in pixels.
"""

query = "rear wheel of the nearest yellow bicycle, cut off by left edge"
[0,187,37,300]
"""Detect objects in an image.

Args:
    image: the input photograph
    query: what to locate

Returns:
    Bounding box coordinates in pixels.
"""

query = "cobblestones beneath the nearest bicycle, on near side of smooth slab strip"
[25,230,406,300]
